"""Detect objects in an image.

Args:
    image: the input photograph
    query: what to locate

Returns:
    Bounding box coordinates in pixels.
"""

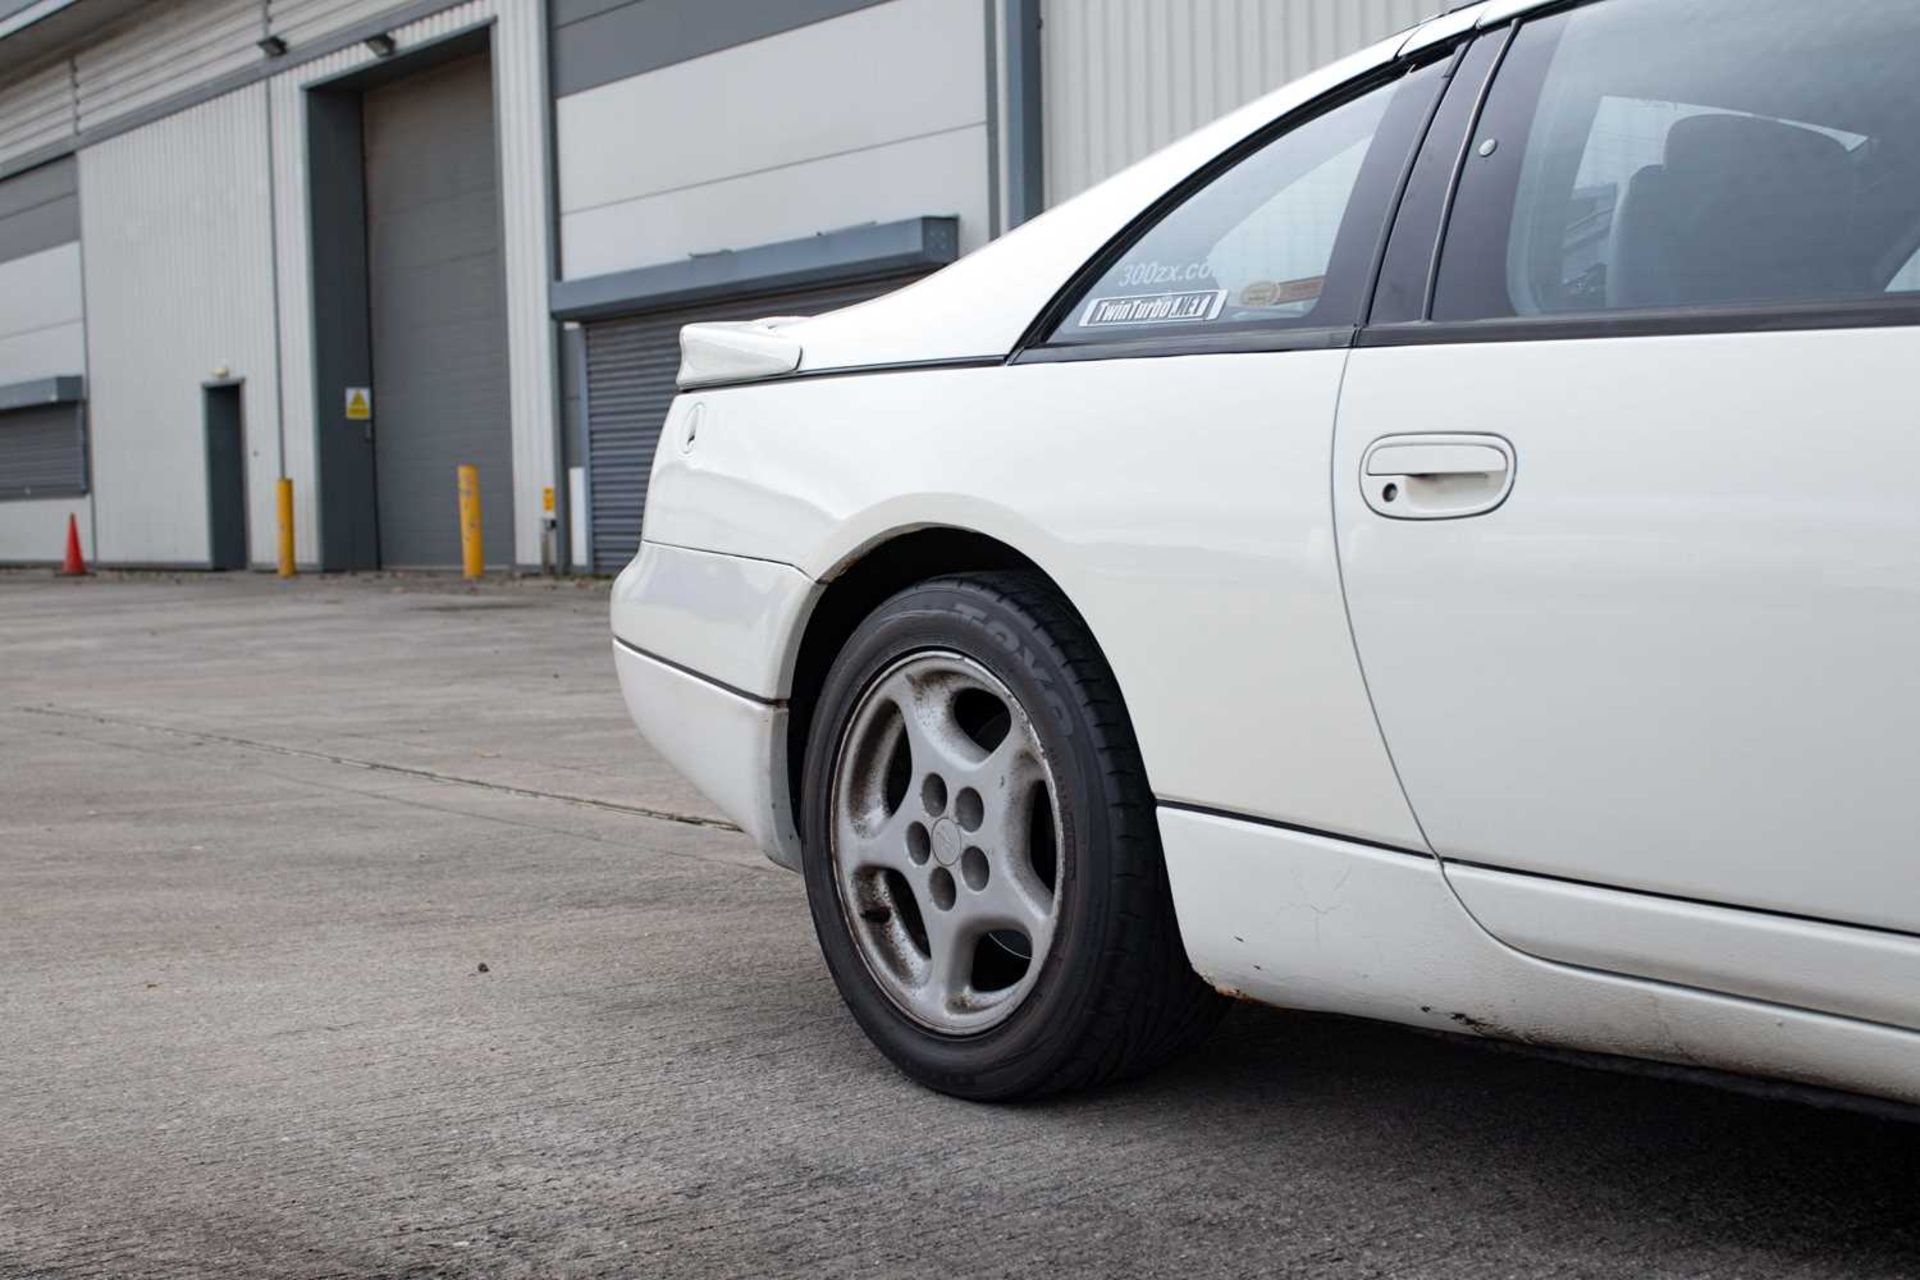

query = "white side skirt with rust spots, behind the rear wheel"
[1160,808,1920,1103]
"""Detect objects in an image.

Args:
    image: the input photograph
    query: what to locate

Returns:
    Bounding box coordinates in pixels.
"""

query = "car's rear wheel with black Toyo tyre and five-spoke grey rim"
[803,572,1225,1102]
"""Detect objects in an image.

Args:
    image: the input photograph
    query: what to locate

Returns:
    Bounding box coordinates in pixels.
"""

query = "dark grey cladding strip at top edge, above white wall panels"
[551,0,883,98]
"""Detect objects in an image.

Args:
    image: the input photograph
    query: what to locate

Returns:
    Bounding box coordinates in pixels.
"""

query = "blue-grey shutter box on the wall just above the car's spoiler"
[549,217,960,320]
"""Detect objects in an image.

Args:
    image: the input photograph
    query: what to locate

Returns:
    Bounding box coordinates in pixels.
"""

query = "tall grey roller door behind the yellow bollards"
[363,54,513,568]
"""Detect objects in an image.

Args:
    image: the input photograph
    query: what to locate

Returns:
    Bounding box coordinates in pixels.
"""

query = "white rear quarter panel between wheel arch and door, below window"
[647,351,1425,848]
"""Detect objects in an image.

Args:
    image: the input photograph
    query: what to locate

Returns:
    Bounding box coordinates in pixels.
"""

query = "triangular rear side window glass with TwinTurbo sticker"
[1048,67,1438,344]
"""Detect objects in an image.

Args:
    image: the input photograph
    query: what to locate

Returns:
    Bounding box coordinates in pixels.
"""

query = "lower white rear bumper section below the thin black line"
[612,639,801,871]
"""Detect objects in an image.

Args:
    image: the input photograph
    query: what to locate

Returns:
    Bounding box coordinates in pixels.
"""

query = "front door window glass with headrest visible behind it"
[1434,0,1920,320]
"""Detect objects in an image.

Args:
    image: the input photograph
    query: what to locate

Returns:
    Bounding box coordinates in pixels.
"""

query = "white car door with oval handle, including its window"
[1334,0,1920,1027]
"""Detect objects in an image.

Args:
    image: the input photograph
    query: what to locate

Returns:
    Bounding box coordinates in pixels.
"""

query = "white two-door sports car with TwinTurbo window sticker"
[612,0,1920,1102]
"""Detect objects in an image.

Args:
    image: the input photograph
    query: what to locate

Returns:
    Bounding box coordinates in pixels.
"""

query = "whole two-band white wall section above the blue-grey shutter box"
[557,0,987,276]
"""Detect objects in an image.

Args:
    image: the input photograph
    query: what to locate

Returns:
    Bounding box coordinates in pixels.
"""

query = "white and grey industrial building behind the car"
[0,0,1436,572]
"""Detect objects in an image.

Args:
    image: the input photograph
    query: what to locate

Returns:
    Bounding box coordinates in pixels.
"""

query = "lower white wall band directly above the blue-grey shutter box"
[561,125,987,278]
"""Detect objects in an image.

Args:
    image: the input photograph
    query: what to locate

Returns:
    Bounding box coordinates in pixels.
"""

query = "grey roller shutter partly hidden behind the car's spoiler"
[586,276,916,574]
